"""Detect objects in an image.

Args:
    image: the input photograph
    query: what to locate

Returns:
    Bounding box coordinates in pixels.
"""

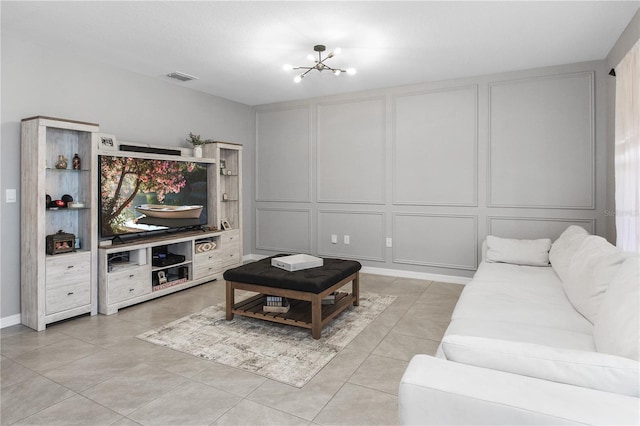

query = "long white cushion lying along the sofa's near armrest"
[441,335,640,398]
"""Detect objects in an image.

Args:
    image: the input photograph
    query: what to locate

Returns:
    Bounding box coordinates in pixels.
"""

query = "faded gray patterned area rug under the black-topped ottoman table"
[137,293,396,388]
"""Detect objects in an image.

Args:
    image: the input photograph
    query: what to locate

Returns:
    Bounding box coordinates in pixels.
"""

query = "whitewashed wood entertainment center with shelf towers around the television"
[21,116,242,331]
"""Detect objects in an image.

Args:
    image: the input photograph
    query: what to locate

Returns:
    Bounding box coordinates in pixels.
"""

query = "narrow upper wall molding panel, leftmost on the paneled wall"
[255,105,313,202]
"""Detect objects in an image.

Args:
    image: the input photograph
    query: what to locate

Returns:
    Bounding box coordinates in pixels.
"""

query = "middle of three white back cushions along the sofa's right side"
[562,235,625,324]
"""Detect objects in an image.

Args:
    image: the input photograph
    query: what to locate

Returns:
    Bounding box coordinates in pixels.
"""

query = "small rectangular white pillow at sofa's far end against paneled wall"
[487,235,551,266]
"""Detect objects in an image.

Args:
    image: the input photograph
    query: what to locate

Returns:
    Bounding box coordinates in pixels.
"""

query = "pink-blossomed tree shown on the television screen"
[100,156,206,235]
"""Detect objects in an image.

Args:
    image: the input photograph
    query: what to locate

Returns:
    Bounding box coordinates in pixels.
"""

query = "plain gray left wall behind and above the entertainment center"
[0,32,254,322]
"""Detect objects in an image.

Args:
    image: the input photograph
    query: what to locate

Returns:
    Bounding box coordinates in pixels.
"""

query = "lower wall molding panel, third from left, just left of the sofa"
[393,213,478,270]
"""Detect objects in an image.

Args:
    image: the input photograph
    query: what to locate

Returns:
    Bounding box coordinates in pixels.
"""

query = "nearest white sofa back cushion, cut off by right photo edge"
[593,255,640,361]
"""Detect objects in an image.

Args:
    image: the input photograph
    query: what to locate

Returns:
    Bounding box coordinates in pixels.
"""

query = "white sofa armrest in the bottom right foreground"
[398,355,640,425]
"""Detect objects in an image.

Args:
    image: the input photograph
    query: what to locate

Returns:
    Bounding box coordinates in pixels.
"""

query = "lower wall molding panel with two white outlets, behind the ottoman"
[318,210,385,262]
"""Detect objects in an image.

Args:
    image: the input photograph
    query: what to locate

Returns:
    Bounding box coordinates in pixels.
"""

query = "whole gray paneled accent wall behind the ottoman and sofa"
[255,61,608,277]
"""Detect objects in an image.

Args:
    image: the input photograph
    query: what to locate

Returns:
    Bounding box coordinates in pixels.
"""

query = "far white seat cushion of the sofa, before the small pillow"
[452,262,593,339]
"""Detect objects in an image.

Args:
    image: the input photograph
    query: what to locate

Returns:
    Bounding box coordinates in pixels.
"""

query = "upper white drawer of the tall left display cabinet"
[45,252,91,292]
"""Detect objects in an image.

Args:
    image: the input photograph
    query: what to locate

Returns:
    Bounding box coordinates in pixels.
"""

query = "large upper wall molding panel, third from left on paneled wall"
[392,85,478,206]
